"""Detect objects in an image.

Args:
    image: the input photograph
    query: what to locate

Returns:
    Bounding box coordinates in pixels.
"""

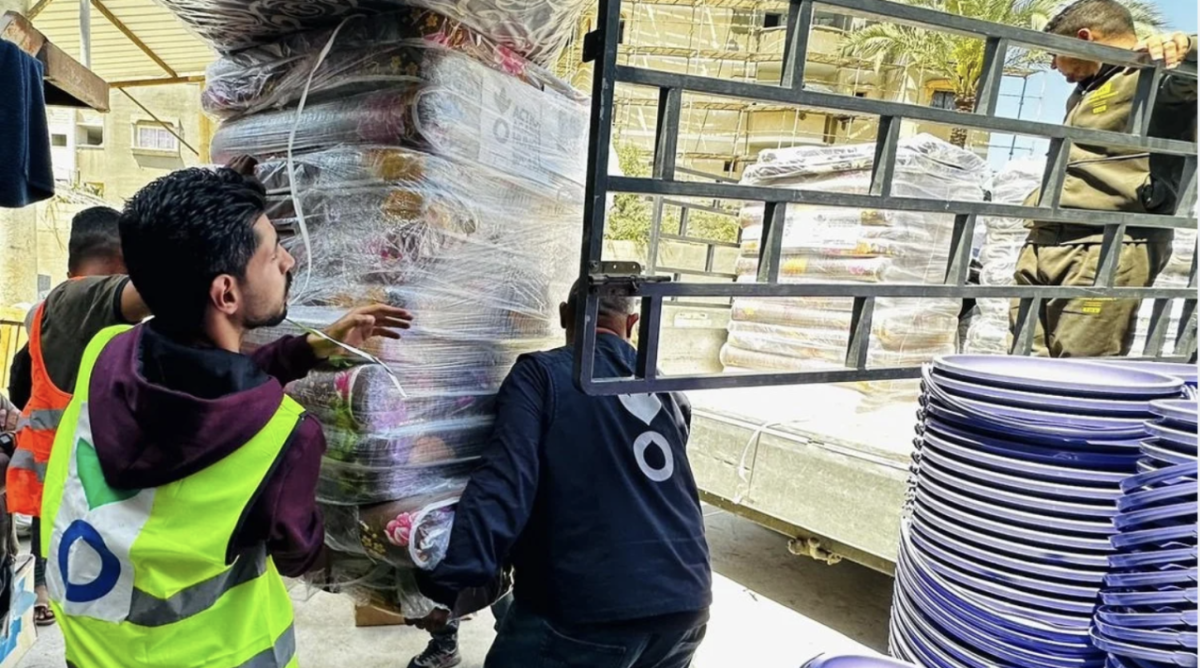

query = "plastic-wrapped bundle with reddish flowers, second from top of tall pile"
[200,7,582,118]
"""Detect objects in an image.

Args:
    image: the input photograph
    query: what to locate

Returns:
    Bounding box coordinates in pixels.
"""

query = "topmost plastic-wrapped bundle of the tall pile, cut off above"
[158,0,586,65]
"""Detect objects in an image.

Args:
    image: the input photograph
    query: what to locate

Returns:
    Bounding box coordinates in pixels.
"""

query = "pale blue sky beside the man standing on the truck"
[989,0,1196,169]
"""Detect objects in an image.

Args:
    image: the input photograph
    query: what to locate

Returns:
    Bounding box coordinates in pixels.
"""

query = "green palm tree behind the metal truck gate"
[844,0,1165,146]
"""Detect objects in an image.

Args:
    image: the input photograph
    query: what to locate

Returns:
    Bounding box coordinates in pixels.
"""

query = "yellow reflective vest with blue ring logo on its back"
[41,326,304,668]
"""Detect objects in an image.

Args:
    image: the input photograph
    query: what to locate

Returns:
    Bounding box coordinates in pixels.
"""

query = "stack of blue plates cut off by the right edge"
[1092,399,1196,668]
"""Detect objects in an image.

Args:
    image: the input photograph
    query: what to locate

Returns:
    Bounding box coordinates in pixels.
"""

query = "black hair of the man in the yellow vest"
[120,168,266,335]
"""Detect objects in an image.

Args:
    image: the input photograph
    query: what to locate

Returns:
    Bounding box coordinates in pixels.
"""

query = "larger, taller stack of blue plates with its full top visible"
[892,355,1183,668]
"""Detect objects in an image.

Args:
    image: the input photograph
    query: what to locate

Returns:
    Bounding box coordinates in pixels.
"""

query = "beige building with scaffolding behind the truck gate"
[559,0,986,177]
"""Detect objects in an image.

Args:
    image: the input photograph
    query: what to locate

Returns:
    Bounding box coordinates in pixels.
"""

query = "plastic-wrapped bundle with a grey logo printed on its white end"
[212,43,588,185]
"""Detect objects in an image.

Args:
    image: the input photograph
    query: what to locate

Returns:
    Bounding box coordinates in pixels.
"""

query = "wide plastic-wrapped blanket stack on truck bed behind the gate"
[721,134,988,402]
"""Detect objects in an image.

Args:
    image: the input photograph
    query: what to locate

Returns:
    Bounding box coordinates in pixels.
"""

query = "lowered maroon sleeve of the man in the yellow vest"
[238,416,325,578]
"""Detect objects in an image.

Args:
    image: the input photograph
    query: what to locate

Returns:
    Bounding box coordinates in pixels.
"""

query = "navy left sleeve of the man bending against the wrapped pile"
[418,357,551,608]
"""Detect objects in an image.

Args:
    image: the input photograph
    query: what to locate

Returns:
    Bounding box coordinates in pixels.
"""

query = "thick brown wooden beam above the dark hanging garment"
[0,12,108,112]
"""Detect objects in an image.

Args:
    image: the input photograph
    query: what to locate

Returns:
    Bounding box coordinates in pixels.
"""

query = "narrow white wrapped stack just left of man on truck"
[962,157,1045,355]
